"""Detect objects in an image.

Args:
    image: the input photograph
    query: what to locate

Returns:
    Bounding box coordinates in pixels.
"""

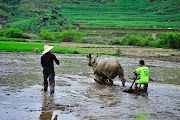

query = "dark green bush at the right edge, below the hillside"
[158,32,180,49]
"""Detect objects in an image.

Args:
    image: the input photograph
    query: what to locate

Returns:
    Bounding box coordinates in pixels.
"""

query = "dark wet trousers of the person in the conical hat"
[43,73,55,94]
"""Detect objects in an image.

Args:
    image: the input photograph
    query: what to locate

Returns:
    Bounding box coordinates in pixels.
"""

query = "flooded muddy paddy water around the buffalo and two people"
[0,53,180,120]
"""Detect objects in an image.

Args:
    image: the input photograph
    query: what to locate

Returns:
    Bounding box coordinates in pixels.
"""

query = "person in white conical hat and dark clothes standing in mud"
[41,45,59,94]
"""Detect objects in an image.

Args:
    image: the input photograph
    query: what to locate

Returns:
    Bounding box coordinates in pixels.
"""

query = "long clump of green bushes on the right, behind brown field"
[108,32,180,49]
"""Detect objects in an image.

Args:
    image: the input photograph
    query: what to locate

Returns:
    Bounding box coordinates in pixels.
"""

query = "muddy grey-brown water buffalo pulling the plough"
[87,54,125,86]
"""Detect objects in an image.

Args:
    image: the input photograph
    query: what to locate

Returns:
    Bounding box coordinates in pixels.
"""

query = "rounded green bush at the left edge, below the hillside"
[0,28,24,38]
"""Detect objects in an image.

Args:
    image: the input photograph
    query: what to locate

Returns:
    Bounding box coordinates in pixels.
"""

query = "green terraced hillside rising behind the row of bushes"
[3,0,180,32]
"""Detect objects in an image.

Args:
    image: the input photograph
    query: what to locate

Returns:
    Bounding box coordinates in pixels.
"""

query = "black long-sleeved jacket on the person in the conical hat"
[41,52,59,74]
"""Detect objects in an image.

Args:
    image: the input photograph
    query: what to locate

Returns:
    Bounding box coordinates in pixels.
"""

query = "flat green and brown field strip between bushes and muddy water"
[0,41,180,62]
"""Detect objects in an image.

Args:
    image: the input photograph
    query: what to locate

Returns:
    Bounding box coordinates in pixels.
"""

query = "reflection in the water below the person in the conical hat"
[39,93,57,120]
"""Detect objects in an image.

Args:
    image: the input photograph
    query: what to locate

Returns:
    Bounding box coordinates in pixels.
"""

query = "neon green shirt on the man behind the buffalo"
[136,66,149,82]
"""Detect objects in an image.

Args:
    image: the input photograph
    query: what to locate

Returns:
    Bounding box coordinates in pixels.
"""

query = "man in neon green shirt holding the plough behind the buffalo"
[133,60,149,92]
